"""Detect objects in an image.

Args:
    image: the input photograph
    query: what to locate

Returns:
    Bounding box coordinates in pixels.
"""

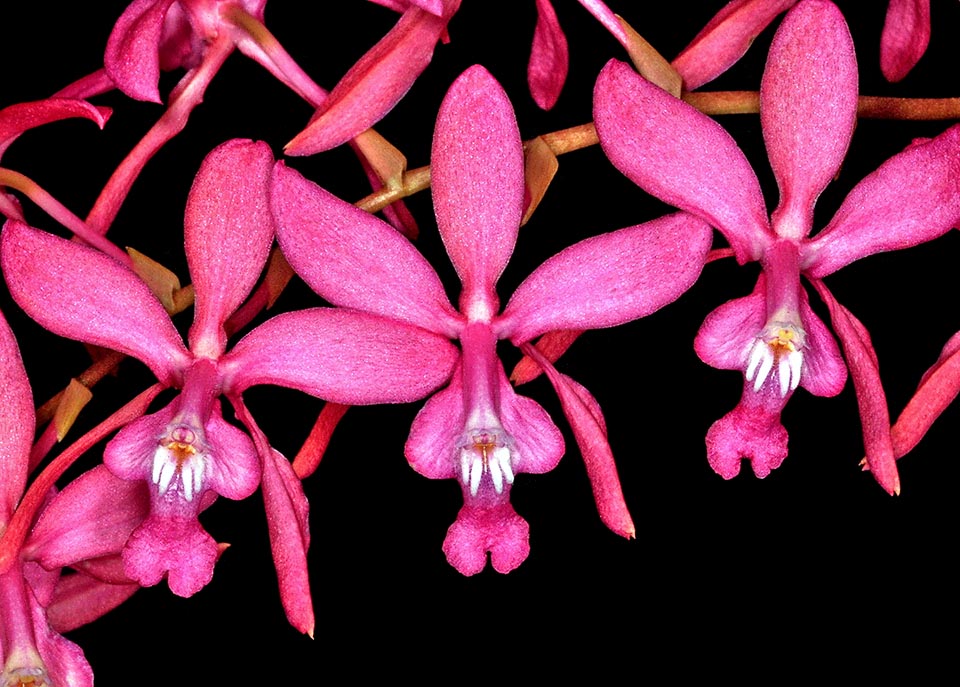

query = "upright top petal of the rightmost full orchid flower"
[760,2,858,239]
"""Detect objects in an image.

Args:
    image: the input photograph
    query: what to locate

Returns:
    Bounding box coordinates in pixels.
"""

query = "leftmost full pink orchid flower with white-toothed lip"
[0,140,456,632]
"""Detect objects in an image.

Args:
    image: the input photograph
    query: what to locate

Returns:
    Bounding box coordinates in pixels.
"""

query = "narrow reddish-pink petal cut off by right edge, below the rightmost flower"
[890,333,960,458]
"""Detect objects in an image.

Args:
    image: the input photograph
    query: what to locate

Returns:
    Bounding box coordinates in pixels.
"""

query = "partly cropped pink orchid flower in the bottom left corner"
[0,315,144,687]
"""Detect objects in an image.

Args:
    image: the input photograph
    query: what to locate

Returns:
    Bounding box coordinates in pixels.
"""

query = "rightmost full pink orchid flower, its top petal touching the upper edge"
[594,0,960,493]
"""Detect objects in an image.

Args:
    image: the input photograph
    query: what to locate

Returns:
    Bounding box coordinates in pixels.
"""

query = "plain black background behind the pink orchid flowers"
[0,0,960,686]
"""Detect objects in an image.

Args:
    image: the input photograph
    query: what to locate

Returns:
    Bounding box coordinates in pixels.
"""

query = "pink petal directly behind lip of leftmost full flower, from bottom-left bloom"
[25,465,150,570]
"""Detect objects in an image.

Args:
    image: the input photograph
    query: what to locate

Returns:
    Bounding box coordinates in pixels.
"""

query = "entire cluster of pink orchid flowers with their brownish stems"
[0,0,960,687]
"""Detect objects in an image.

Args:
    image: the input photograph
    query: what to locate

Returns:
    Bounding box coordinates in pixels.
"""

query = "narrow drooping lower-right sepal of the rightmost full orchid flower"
[812,280,900,494]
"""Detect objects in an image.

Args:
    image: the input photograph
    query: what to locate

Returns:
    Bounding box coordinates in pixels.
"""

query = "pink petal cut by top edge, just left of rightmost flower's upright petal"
[672,0,797,91]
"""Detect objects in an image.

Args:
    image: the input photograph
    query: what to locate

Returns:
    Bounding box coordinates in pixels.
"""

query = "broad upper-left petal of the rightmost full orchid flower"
[593,60,772,263]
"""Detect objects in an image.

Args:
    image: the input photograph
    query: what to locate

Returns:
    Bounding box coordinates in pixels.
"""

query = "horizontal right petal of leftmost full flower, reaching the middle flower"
[220,308,459,405]
